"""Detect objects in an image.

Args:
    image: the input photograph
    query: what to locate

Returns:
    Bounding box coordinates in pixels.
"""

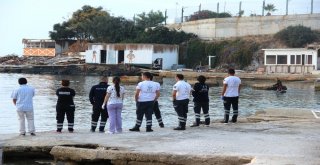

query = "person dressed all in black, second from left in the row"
[56,80,76,133]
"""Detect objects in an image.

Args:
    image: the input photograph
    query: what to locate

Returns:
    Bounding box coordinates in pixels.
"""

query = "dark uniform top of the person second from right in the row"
[192,83,209,102]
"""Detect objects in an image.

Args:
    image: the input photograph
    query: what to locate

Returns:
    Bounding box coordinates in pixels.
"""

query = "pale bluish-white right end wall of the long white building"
[152,50,178,70]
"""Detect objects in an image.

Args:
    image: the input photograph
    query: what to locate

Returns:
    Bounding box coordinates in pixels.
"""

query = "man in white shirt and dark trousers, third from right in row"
[172,74,191,130]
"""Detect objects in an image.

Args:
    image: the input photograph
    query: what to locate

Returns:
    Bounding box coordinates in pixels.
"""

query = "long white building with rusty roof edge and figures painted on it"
[86,43,179,69]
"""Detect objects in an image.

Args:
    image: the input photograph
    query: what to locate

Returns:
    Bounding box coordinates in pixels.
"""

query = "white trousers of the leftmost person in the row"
[17,111,35,134]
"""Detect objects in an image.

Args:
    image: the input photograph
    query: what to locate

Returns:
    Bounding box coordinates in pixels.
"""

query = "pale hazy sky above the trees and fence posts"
[0,0,320,56]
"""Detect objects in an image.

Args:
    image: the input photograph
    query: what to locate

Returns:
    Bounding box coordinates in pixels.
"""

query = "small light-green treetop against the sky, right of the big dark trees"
[134,10,166,30]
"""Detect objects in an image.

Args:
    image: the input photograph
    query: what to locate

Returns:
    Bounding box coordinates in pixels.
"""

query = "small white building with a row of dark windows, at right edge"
[263,48,320,73]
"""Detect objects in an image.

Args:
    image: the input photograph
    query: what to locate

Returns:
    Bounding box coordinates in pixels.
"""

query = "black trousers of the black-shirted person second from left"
[56,105,75,131]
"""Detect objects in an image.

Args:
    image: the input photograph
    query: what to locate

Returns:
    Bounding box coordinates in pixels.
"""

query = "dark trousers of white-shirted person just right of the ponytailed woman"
[136,101,154,128]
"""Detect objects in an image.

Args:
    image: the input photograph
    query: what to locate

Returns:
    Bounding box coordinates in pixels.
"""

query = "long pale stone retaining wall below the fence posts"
[168,14,320,40]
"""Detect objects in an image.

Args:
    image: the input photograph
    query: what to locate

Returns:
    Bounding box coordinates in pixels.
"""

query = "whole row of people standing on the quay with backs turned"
[11,69,241,136]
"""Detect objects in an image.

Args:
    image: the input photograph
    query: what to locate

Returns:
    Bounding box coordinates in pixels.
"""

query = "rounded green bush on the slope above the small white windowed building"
[275,25,317,48]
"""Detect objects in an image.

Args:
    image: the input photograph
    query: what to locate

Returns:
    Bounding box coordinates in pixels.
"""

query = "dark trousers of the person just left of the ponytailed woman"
[91,105,108,131]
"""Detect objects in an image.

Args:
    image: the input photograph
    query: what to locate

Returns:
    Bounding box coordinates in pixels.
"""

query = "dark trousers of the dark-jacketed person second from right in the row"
[193,102,210,125]
